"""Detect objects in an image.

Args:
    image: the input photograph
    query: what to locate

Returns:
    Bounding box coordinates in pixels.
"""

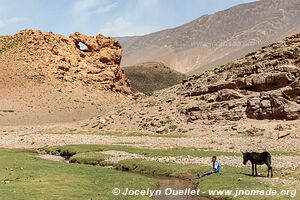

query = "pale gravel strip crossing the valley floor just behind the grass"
[0,130,300,151]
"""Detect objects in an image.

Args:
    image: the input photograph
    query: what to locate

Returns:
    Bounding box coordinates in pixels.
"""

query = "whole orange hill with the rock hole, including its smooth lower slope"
[0,30,132,125]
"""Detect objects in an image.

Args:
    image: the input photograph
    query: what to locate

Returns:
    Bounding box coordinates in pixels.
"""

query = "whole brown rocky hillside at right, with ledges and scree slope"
[91,34,300,133]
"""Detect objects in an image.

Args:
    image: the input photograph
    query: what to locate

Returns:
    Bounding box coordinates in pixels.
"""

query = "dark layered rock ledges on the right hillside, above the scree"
[177,34,300,120]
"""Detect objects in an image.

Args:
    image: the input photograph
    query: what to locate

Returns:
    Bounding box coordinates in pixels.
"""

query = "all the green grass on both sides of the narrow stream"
[0,145,300,200]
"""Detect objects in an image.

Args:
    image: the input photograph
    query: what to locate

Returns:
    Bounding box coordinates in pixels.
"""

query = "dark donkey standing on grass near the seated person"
[242,151,273,178]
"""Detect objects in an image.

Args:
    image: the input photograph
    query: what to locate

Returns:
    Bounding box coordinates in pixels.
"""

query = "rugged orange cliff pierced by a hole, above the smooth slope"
[0,30,132,94]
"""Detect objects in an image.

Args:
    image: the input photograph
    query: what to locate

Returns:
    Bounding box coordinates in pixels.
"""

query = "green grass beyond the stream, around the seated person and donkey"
[41,145,299,200]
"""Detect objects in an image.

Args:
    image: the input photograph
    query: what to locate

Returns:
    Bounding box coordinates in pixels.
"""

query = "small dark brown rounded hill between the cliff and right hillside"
[122,62,185,95]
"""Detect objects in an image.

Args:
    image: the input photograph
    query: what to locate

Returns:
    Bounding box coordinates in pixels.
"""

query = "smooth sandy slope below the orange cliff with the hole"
[0,84,129,128]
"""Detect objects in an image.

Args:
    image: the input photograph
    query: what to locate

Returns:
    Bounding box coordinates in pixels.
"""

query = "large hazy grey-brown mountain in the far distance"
[118,0,300,73]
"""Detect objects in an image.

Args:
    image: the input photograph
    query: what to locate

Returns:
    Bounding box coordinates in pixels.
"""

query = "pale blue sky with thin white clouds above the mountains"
[0,0,254,37]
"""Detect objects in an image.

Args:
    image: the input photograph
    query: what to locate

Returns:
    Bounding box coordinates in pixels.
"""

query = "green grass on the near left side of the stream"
[0,149,158,200]
